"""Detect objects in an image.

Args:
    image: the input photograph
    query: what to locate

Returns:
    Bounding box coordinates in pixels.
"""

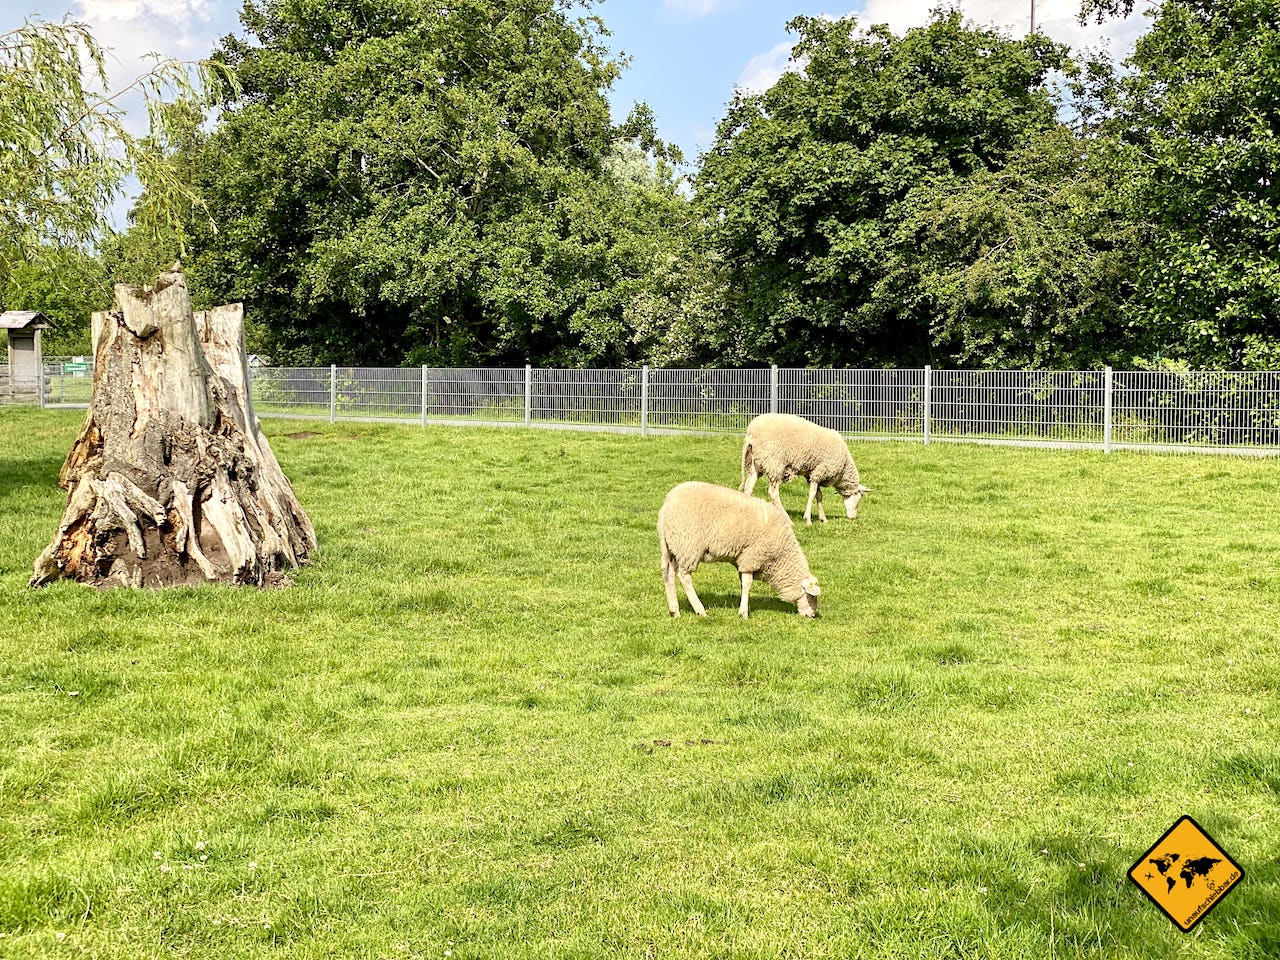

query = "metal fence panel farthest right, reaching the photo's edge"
[1111,370,1280,448]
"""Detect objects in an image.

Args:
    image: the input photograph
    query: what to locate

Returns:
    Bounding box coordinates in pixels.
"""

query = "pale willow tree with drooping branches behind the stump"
[0,20,220,351]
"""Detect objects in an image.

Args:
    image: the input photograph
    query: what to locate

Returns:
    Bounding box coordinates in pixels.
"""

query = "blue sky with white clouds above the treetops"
[0,0,1146,208]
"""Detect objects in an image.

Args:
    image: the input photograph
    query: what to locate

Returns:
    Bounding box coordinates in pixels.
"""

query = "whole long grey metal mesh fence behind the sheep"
[27,358,1280,454]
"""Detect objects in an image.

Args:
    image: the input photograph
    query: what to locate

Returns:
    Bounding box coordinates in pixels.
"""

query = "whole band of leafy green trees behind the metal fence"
[0,0,1280,369]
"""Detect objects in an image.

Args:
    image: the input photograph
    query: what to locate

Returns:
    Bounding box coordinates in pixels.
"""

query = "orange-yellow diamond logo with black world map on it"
[1129,817,1244,933]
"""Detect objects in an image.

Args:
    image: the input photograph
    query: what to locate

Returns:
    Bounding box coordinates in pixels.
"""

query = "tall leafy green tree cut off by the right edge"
[1083,0,1280,369]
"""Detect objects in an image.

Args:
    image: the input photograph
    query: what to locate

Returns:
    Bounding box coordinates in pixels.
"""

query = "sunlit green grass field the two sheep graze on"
[0,408,1280,960]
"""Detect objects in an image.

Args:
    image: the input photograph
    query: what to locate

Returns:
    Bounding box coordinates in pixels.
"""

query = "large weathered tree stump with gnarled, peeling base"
[31,264,316,586]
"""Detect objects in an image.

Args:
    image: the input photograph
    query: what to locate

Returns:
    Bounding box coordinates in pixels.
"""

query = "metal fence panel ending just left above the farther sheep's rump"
[649,367,769,433]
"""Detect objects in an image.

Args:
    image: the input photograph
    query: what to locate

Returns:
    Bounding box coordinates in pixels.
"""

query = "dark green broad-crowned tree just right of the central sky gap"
[696,12,1068,365]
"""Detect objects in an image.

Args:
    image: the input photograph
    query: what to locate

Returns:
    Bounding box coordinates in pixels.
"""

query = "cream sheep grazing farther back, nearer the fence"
[742,413,870,524]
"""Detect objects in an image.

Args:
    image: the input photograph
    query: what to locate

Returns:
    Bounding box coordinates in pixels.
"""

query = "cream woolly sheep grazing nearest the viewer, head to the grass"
[658,481,819,618]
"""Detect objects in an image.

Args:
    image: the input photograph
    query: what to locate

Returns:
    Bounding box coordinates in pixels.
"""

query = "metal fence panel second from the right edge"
[929,370,1106,447]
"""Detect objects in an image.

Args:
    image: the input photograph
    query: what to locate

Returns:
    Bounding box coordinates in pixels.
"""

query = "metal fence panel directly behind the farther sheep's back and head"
[778,367,924,438]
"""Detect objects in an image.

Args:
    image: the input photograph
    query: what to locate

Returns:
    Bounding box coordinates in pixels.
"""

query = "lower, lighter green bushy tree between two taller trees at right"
[873,127,1151,369]
